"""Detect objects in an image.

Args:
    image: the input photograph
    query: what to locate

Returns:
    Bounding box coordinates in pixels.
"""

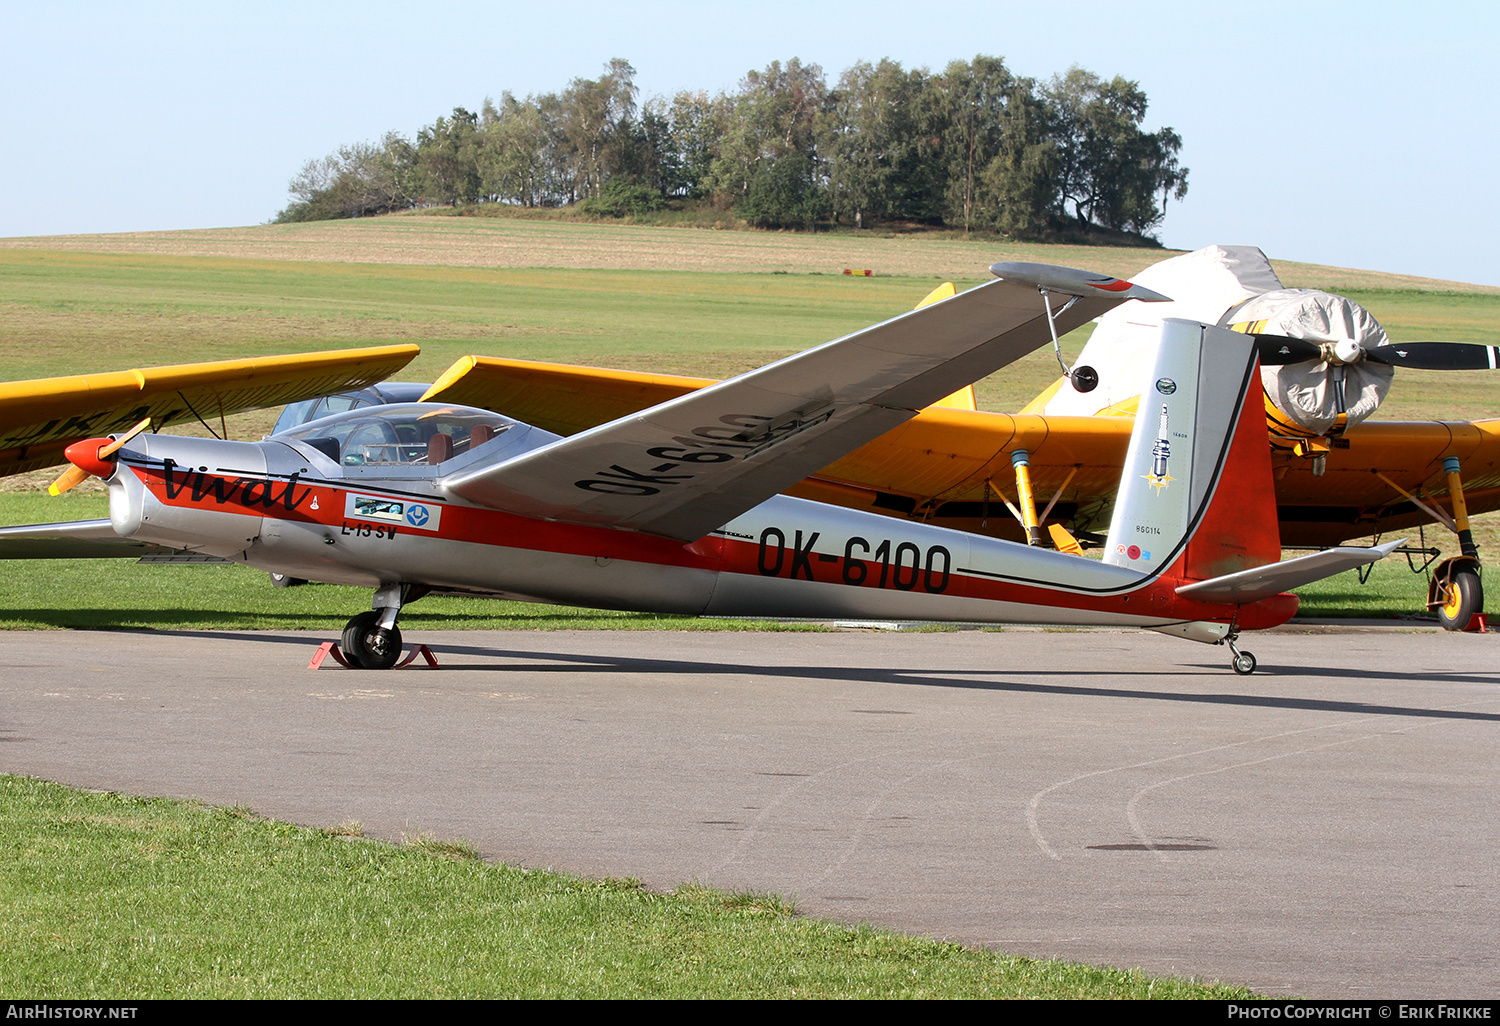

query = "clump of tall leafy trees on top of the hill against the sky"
[278,56,1188,239]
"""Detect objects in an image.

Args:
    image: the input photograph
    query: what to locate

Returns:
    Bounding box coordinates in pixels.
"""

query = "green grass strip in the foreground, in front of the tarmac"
[0,776,1253,999]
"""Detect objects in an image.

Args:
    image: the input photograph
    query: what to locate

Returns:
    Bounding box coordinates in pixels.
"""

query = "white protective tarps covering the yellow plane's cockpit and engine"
[1041,246,1392,434]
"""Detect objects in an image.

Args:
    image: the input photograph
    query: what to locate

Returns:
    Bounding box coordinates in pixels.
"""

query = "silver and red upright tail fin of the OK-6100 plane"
[1104,320,1281,581]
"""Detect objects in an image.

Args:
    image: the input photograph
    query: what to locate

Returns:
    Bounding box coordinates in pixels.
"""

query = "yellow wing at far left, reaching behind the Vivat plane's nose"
[0,345,422,476]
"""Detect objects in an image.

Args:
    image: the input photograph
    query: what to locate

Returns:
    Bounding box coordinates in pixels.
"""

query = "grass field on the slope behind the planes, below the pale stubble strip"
[0,241,1500,420]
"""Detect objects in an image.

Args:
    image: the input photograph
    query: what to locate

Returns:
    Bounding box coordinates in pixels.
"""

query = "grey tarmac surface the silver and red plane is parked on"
[0,629,1500,999]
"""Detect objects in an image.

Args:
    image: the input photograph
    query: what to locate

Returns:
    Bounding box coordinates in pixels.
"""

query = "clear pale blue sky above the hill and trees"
[0,0,1500,285]
